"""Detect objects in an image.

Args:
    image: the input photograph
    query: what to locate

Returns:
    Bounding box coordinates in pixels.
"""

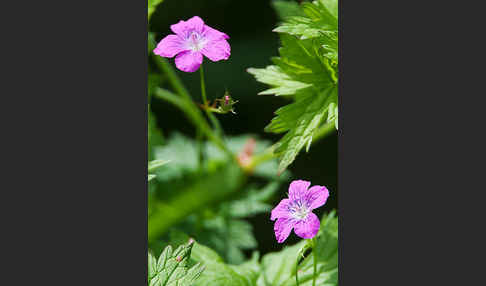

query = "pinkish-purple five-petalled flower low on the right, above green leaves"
[271,180,329,243]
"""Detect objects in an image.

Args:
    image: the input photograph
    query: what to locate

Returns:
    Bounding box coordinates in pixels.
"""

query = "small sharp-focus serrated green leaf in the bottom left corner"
[148,242,204,286]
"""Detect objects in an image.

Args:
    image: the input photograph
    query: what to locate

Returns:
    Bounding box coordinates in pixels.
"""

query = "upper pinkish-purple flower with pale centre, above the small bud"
[154,16,231,72]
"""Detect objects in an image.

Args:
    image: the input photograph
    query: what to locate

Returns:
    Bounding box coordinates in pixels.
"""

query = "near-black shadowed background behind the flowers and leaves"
[149,0,339,253]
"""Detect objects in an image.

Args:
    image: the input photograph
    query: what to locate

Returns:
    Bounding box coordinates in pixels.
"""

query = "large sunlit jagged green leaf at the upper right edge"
[248,0,338,173]
